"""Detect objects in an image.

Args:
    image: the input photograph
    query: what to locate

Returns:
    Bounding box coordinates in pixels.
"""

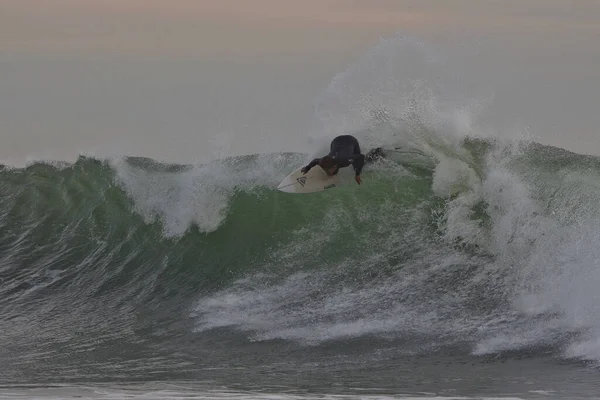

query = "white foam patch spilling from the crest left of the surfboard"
[112,154,302,237]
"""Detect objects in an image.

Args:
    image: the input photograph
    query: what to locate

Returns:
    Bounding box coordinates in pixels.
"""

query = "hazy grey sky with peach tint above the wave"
[0,0,600,164]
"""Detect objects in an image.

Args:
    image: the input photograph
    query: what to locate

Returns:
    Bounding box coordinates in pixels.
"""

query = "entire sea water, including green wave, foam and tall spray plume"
[0,37,600,399]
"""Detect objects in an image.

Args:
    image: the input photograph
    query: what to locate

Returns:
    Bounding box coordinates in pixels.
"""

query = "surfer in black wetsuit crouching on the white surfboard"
[302,135,381,185]
